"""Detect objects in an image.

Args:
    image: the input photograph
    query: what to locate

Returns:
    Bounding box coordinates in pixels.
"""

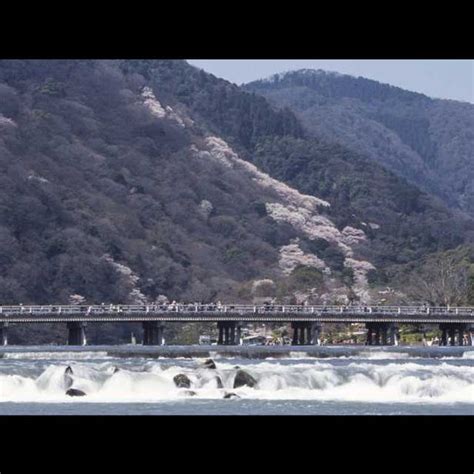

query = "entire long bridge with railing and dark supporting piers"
[0,303,474,345]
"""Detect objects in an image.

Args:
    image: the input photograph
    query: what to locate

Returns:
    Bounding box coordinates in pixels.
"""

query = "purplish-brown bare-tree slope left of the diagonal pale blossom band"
[0,61,300,303]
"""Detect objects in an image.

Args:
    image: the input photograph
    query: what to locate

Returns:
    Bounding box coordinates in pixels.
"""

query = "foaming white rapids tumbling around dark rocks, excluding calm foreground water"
[0,353,474,404]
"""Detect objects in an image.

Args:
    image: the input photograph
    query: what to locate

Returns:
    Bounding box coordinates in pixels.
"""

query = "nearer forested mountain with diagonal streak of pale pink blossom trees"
[0,60,474,340]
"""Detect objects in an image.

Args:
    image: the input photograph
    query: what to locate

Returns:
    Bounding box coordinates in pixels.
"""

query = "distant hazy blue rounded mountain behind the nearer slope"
[244,69,474,216]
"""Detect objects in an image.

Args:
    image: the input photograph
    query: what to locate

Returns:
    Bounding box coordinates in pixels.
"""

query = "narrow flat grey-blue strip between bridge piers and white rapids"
[0,345,474,359]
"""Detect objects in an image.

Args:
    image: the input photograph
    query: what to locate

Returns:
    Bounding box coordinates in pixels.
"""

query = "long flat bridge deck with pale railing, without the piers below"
[0,304,474,324]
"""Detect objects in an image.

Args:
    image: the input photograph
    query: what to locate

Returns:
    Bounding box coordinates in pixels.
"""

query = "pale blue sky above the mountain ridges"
[188,59,474,103]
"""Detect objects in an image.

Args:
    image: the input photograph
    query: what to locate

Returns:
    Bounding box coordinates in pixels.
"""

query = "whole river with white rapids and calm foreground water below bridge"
[0,347,474,415]
